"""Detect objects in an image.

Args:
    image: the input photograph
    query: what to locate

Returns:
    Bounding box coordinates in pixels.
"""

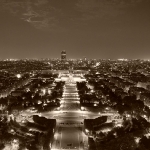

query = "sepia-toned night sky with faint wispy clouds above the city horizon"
[0,0,150,59]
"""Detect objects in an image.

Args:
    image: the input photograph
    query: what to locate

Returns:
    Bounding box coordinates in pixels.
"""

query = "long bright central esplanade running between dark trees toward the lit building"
[52,78,87,150]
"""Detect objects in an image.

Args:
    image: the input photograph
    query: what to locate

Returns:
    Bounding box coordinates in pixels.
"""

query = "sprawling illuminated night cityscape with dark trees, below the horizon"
[0,53,150,150]
